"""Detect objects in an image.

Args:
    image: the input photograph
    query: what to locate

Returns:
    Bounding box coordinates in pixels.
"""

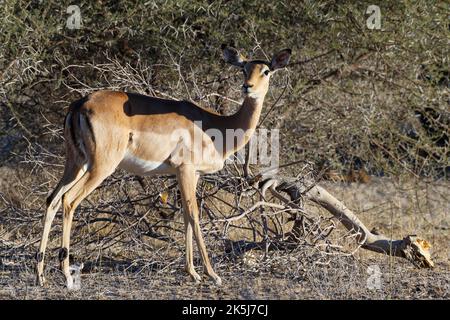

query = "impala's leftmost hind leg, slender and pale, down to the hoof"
[36,162,86,286]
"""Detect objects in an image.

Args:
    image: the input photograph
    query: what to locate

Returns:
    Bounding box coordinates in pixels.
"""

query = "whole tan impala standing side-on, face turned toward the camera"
[37,46,291,289]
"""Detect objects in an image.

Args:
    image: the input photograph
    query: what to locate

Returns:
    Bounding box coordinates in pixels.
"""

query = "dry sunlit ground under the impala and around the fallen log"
[0,172,450,299]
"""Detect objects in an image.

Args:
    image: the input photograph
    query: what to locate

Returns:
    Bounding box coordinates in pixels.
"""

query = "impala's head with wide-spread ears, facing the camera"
[222,45,291,99]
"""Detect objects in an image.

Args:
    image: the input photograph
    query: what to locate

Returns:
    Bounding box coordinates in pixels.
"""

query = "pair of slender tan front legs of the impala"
[177,165,222,285]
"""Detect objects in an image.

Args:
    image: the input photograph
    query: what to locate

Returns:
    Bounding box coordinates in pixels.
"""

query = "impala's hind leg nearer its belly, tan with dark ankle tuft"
[59,167,115,290]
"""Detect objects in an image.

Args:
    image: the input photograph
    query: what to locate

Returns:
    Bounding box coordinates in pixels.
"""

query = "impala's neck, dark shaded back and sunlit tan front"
[222,96,264,158]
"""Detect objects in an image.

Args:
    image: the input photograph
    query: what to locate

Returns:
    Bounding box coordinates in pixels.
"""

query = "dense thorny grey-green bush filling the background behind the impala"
[0,0,450,179]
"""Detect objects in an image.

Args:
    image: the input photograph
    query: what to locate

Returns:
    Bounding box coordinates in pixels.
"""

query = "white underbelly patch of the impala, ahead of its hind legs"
[119,152,175,175]
